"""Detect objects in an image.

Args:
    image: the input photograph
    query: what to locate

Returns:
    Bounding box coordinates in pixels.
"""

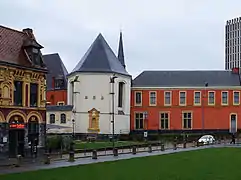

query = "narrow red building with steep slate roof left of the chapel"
[43,53,68,106]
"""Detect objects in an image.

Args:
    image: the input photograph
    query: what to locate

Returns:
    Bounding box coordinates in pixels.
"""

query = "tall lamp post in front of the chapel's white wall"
[110,75,117,149]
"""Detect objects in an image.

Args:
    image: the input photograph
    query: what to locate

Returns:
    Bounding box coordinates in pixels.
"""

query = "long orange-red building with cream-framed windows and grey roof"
[131,70,241,132]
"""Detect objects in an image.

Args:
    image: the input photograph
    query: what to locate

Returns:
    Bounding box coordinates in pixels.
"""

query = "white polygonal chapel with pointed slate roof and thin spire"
[68,33,131,135]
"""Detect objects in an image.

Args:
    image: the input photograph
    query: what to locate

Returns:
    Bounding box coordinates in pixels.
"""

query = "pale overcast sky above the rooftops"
[0,0,241,76]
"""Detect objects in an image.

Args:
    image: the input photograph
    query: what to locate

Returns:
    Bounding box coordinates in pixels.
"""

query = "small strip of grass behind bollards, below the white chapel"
[75,141,141,149]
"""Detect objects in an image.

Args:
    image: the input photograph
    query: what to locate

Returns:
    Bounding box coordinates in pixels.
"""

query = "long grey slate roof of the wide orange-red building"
[132,71,240,87]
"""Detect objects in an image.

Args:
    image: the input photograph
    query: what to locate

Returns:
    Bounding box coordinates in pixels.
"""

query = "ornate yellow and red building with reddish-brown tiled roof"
[0,26,47,157]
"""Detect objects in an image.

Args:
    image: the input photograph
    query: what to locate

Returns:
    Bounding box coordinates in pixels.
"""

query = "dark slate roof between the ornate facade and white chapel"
[43,53,68,90]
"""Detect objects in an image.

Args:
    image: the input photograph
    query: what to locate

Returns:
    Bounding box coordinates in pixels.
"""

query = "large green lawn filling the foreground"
[0,148,241,180]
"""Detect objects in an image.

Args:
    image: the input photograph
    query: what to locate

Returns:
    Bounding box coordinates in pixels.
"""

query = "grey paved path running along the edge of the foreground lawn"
[0,144,240,174]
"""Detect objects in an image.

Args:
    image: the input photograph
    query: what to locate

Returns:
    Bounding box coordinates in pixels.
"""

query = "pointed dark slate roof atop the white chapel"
[72,34,130,76]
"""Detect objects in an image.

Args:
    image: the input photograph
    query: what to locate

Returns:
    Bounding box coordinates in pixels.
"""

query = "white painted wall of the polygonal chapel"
[68,73,131,134]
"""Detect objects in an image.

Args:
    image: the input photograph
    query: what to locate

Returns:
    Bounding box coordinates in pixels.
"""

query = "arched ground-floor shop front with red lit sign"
[0,111,45,157]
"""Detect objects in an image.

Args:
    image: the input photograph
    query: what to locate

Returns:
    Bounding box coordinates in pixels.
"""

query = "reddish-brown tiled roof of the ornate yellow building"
[0,25,46,71]
